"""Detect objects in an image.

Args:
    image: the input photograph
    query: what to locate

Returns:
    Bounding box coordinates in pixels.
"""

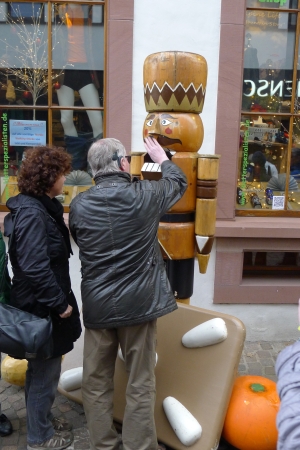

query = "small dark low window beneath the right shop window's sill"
[243,251,300,279]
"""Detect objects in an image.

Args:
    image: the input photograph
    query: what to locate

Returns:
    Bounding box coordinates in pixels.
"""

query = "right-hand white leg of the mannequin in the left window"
[79,83,103,137]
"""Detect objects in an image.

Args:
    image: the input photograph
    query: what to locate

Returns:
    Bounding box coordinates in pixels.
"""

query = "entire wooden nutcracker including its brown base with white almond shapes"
[59,51,245,450]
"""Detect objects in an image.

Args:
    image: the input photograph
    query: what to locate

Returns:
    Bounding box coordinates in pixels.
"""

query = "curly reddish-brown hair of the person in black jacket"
[18,146,72,196]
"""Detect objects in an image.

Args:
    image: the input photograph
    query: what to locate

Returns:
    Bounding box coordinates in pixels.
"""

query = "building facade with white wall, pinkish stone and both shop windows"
[0,0,300,322]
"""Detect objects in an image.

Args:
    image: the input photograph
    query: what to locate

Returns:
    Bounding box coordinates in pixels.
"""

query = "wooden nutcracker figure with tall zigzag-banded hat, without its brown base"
[142,51,218,303]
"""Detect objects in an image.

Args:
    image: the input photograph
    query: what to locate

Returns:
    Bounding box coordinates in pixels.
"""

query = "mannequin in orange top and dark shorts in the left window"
[56,3,103,170]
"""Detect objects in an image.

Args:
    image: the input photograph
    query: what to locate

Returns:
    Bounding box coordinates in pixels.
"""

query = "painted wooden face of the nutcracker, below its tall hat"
[143,112,204,152]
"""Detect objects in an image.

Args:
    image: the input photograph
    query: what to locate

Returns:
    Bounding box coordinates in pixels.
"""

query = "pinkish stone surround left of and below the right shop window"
[214,0,300,304]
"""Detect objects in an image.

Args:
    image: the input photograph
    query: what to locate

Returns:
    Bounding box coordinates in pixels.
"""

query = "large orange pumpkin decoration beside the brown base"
[222,375,280,450]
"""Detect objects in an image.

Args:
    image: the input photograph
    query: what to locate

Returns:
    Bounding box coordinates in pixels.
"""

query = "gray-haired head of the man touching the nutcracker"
[88,138,126,176]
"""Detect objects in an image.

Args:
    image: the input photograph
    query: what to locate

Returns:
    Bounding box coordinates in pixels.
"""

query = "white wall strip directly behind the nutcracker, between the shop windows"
[131,0,223,306]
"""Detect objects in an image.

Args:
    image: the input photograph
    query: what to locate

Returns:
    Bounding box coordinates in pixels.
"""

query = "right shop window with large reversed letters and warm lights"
[236,0,300,216]
